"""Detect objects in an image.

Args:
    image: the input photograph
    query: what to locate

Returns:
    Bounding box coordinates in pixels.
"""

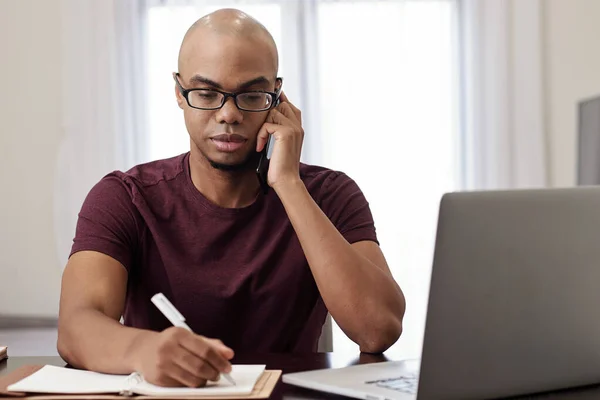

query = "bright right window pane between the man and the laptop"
[318,1,459,357]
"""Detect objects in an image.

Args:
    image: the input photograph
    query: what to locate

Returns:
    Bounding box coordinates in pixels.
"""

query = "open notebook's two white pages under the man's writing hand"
[7,365,265,398]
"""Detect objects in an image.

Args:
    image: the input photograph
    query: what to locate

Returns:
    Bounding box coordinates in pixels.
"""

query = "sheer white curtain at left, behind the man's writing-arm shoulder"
[54,0,147,263]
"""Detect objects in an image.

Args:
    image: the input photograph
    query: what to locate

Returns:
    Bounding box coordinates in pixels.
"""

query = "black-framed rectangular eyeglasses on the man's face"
[174,73,283,112]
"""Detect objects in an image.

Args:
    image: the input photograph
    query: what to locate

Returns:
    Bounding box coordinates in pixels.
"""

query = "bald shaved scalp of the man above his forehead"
[177,8,279,73]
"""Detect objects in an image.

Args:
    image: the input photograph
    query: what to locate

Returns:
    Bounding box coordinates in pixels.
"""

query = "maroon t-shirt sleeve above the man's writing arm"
[70,175,139,271]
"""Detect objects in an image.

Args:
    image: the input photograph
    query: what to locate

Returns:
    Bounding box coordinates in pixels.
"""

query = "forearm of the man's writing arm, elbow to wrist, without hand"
[58,309,158,374]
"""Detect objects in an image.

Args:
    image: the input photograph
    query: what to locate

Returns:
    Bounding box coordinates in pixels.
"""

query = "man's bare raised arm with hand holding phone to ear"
[256,94,405,353]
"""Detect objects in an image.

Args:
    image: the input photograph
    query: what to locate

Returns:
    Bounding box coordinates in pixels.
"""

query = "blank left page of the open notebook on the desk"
[7,365,127,394]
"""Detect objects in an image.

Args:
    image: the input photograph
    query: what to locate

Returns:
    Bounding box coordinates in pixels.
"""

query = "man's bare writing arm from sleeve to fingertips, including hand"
[58,251,233,387]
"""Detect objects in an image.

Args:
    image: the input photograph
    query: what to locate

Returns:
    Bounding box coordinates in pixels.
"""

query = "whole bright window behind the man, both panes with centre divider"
[148,0,460,357]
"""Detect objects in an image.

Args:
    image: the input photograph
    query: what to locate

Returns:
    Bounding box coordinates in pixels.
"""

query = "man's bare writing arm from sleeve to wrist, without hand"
[58,251,156,374]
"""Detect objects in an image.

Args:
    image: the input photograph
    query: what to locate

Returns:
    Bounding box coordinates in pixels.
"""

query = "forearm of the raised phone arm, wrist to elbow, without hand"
[278,181,404,352]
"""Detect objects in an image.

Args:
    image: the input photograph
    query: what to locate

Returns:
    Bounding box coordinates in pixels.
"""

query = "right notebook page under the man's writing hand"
[131,365,266,397]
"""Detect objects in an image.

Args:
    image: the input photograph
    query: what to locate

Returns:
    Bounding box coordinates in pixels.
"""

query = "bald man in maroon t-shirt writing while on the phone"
[58,9,405,387]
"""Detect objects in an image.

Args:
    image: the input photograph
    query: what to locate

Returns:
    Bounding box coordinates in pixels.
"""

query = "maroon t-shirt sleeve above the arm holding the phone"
[319,172,379,244]
